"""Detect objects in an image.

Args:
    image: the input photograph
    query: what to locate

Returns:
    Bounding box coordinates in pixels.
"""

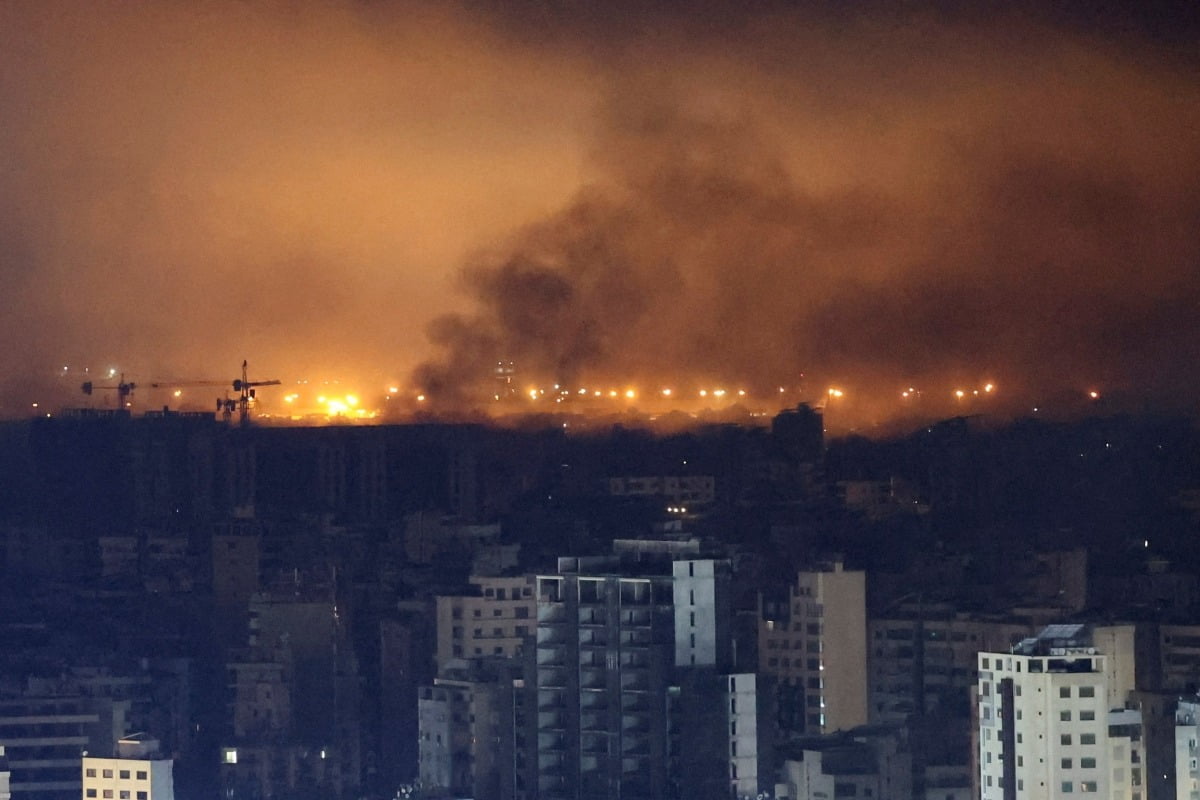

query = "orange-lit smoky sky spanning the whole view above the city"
[0,2,1200,416]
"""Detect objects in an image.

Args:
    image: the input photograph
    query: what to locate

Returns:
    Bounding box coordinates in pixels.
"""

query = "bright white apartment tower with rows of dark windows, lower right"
[977,625,1144,800]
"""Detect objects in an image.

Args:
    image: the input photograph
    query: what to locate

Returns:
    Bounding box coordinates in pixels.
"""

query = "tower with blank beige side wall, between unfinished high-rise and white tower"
[758,561,869,733]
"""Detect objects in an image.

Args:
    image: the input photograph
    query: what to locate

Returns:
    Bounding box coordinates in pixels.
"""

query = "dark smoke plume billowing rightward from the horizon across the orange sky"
[418,9,1200,419]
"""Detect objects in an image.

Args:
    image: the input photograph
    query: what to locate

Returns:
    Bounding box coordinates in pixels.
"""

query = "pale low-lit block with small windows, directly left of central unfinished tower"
[437,576,536,672]
